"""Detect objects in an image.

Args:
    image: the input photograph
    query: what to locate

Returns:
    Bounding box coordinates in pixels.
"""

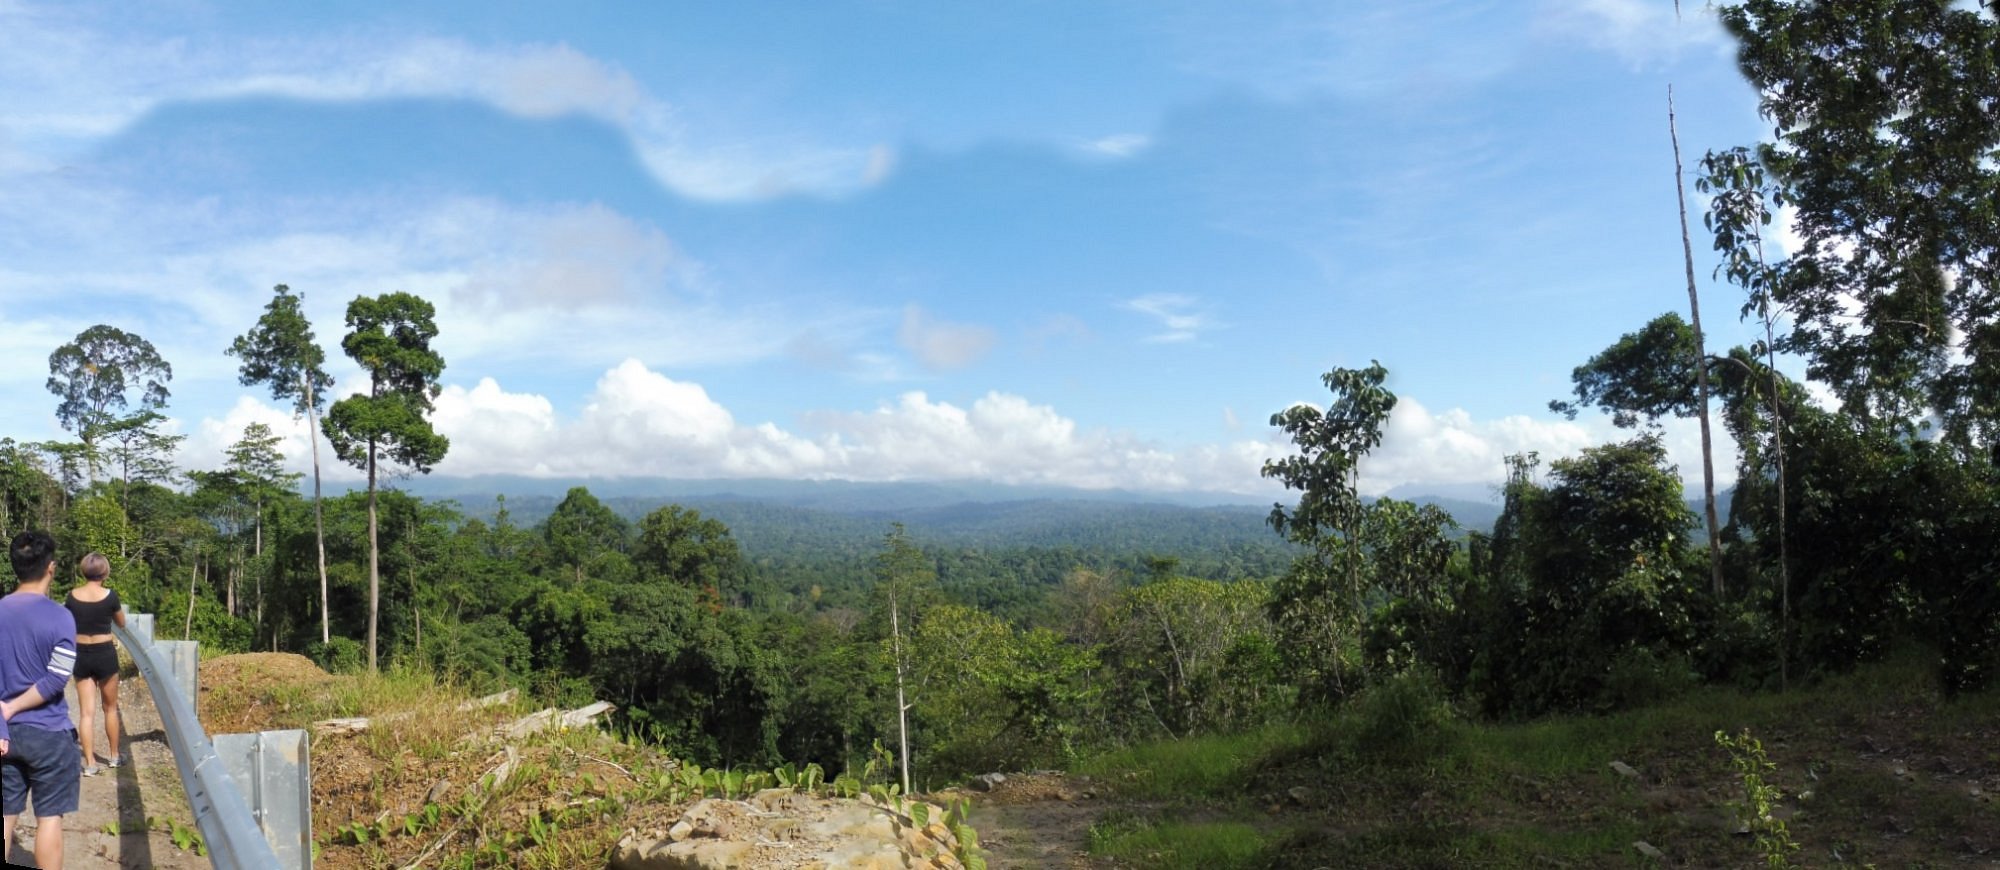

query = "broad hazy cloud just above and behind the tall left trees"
[0,198,804,392]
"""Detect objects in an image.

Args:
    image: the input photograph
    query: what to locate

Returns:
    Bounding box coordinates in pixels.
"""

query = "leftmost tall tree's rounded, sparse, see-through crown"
[48,324,174,480]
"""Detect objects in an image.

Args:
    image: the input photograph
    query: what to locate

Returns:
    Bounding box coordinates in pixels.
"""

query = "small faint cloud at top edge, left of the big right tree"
[1536,0,1730,66]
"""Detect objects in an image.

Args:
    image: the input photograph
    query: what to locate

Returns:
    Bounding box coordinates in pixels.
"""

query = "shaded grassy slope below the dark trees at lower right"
[1082,654,2000,868]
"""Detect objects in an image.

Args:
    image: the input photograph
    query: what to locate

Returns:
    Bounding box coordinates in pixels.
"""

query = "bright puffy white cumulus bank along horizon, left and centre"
[182,360,1274,492]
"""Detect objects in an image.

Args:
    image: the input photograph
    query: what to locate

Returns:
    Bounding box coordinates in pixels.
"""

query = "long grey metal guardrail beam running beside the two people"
[112,614,284,870]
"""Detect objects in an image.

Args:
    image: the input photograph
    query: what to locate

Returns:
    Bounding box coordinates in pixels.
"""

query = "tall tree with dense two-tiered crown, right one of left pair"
[324,292,452,672]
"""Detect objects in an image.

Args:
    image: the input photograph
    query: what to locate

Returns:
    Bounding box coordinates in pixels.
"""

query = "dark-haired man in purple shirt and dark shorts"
[0,532,84,870]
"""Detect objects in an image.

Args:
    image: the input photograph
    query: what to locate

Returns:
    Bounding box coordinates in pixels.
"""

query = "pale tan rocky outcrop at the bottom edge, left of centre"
[610,788,964,870]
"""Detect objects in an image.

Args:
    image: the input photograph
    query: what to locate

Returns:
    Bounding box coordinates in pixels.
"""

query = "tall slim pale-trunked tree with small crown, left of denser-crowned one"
[228,284,334,644]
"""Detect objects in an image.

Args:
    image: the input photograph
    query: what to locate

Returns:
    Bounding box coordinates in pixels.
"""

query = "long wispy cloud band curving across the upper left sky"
[0,6,896,200]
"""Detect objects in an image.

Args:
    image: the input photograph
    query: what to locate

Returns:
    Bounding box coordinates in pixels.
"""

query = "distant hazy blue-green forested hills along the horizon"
[372,478,1498,618]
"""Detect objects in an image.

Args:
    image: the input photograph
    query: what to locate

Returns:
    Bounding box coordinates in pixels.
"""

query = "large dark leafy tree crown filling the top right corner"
[1720,0,2000,456]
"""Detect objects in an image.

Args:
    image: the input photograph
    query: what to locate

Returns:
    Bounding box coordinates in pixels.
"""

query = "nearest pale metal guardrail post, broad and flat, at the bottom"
[216,730,312,870]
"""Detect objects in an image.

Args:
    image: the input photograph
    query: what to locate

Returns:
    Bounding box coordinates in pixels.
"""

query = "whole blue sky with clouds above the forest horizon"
[0,0,1766,494]
